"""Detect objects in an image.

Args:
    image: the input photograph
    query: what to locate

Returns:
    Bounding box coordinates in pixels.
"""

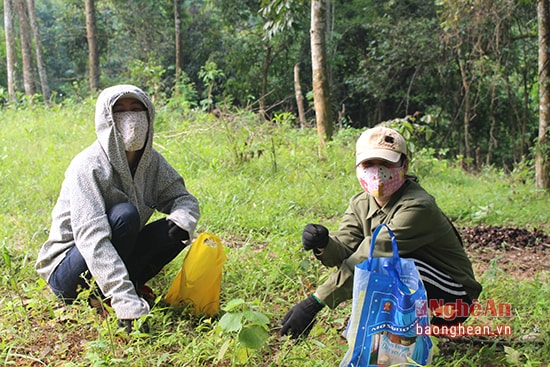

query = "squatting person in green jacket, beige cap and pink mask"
[280,126,481,338]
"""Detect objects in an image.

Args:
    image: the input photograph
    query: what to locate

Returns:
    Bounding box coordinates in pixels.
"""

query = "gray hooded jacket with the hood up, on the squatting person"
[36,85,200,319]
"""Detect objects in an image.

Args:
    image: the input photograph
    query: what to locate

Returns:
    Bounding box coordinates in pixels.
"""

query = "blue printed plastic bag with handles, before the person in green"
[340,224,432,367]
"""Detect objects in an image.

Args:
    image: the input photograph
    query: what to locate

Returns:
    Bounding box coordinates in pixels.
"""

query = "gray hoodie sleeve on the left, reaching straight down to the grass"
[67,162,149,319]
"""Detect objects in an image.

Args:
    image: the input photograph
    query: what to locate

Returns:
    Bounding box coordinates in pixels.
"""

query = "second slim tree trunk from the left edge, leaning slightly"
[15,0,36,97]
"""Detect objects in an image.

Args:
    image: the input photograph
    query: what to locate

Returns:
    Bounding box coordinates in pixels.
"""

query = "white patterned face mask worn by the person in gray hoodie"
[113,111,149,152]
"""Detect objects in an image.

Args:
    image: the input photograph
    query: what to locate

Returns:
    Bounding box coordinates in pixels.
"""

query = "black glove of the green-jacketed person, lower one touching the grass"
[279,295,324,339]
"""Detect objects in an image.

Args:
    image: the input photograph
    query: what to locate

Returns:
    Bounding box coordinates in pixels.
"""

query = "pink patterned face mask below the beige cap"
[357,165,405,198]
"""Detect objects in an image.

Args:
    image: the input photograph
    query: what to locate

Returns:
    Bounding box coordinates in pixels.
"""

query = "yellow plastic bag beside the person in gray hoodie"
[164,233,227,316]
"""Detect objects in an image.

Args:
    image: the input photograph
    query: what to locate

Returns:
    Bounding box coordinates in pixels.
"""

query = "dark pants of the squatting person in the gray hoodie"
[49,203,185,303]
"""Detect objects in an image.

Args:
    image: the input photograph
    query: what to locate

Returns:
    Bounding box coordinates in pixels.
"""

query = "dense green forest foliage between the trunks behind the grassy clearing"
[0,0,538,169]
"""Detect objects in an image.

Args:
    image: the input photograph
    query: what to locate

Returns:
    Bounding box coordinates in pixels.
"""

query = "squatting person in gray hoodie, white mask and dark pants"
[36,85,200,331]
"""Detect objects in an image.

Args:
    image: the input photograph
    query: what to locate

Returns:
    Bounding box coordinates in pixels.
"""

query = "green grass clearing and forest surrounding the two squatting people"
[0,0,550,366]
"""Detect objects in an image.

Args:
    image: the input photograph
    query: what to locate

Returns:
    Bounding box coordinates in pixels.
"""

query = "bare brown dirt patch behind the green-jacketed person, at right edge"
[460,226,550,279]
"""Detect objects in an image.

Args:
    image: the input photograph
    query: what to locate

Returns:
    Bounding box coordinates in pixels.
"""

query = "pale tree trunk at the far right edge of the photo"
[535,0,550,191]
